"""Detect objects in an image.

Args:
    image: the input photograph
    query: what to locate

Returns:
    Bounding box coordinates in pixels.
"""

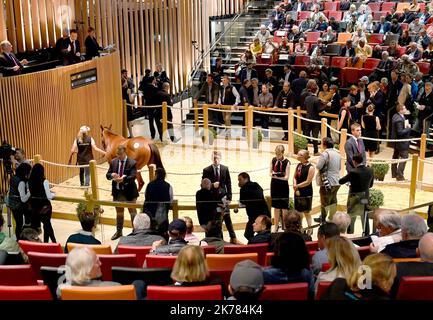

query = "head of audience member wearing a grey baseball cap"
[228,260,264,301]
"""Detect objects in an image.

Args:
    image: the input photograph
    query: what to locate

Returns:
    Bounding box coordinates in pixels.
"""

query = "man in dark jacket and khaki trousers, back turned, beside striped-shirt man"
[338,153,373,235]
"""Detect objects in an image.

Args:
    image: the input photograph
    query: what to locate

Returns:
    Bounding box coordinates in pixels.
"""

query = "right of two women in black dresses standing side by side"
[293,150,315,235]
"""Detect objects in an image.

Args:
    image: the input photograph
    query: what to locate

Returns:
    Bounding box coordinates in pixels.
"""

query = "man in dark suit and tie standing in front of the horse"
[106,145,138,240]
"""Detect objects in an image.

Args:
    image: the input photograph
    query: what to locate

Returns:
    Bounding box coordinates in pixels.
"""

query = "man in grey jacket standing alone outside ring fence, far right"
[391,105,411,181]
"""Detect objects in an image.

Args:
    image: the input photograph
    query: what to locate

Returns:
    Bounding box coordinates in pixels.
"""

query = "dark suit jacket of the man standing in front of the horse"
[106,158,138,201]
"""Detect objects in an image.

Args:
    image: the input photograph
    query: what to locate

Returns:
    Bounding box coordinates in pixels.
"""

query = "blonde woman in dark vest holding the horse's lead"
[68,126,105,186]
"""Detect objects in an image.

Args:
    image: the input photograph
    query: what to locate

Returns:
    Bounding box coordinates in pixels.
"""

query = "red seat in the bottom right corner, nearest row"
[397,277,433,300]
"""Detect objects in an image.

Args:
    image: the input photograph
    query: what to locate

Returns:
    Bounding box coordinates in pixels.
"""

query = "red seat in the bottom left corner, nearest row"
[0,286,53,300]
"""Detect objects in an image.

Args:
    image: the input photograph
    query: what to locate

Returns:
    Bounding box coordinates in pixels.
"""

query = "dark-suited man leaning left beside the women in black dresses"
[238,172,271,241]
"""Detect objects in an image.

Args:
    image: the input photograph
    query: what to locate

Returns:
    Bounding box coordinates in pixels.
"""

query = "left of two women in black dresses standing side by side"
[269,145,290,232]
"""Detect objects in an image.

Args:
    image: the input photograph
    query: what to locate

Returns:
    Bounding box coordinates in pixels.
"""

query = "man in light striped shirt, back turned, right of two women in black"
[314,137,341,223]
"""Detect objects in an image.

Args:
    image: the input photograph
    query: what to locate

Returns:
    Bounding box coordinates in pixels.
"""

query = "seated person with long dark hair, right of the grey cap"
[263,232,314,292]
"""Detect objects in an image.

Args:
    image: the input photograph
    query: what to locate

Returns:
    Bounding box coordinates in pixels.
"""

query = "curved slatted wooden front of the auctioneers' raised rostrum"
[0,52,123,190]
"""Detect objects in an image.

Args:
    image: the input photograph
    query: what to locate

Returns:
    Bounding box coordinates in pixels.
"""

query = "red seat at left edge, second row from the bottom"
[0,264,38,286]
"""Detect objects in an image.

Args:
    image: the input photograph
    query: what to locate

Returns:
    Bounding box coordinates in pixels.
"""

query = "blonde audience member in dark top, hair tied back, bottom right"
[321,253,397,300]
